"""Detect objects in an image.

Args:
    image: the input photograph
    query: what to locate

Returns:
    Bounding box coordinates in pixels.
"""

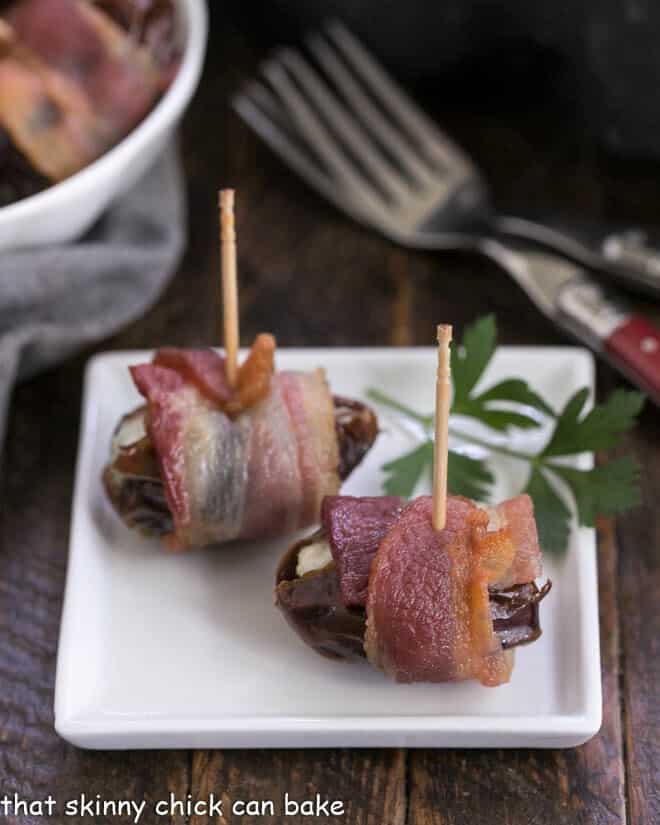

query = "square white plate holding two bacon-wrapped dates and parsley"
[55,348,601,748]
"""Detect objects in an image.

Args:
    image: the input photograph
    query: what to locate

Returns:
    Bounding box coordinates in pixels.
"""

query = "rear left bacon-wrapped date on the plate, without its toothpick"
[103,335,378,549]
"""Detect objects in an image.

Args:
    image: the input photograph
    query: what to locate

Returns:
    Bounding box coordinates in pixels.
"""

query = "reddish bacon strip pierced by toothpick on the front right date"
[365,496,540,686]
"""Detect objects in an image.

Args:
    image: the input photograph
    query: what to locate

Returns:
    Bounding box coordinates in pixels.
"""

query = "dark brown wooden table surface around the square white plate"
[0,8,660,825]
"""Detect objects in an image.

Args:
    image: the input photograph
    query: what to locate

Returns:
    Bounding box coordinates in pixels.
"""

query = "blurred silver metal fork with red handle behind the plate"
[233,23,660,404]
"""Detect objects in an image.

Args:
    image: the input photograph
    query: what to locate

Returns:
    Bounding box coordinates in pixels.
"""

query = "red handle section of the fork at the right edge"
[604,315,660,403]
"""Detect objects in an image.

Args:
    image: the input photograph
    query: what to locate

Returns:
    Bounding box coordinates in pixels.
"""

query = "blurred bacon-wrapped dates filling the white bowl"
[0,0,179,206]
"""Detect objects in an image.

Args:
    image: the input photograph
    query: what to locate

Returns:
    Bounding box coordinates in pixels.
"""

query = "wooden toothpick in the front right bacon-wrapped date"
[433,324,452,530]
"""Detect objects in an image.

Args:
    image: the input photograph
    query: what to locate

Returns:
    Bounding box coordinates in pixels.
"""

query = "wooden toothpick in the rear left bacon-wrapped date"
[218,189,240,387]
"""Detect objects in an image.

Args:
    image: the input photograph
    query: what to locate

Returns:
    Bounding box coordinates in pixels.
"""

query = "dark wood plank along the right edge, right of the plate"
[618,409,660,825]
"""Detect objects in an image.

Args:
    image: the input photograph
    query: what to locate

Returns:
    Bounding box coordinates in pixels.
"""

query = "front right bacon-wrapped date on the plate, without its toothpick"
[275,495,551,686]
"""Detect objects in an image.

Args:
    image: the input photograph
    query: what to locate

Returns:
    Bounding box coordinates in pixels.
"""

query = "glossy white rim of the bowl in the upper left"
[0,0,208,225]
